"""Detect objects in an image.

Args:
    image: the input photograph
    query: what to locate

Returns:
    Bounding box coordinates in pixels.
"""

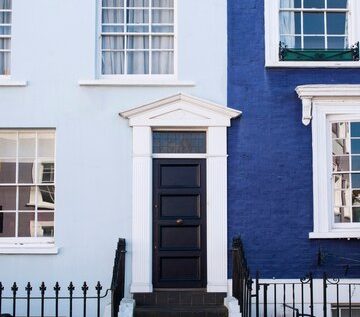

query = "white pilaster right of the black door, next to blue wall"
[207,127,227,293]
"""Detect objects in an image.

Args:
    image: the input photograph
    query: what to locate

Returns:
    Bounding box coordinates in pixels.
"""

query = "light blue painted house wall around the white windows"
[0,0,227,308]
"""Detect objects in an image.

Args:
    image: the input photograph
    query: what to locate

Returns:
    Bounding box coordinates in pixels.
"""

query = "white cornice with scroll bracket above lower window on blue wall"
[295,85,360,125]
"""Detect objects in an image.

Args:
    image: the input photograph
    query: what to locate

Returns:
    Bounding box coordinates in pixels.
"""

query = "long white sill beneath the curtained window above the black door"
[78,79,195,87]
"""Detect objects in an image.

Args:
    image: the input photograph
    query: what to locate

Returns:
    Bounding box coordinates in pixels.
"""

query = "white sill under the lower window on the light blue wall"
[0,243,59,254]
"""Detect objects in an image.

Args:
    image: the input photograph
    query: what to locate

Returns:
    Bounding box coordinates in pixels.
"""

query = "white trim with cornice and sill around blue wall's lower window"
[296,85,360,239]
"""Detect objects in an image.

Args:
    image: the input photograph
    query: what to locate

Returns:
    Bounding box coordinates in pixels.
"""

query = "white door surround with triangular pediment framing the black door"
[120,94,241,293]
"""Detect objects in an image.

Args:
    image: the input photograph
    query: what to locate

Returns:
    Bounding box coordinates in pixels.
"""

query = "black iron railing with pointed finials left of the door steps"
[0,239,126,317]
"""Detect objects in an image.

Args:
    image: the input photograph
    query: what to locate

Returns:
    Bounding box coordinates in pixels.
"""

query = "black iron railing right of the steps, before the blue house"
[232,237,360,317]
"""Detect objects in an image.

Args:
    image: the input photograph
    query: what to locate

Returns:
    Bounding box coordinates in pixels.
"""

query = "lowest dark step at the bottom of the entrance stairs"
[134,305,228,317]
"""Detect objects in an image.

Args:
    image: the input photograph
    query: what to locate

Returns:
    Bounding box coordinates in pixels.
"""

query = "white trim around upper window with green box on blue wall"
[264,0,360,68]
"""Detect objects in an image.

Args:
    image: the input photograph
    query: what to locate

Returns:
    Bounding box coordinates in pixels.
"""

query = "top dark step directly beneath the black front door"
[134,290,226,307]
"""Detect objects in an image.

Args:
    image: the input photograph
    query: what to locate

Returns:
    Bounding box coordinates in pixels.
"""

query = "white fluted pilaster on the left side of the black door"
[131,127,152,293]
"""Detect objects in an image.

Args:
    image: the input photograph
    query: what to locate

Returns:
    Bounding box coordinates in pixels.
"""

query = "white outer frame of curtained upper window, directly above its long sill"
[96,0,178,79]
